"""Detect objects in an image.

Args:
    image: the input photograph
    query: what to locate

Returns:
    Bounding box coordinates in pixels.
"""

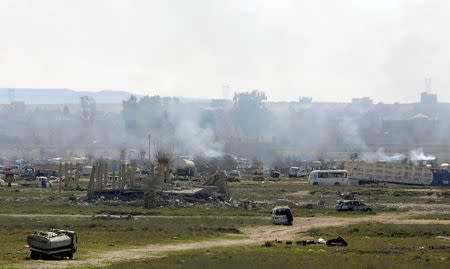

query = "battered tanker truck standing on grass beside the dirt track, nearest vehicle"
[27,229,78,260]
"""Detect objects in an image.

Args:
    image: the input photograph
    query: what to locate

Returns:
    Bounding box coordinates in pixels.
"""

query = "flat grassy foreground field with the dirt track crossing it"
[0,175,450,268]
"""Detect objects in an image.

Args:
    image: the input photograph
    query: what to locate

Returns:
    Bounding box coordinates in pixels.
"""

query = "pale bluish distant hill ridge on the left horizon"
[0,88,139,104]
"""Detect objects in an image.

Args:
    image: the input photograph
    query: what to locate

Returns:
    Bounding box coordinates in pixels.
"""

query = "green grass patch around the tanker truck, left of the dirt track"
[0,216,267,267]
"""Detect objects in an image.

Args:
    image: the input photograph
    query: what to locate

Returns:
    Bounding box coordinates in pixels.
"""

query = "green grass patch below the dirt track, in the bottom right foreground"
[108,223,450,269]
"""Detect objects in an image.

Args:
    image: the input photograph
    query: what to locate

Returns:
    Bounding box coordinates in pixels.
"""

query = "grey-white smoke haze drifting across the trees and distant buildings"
[0,91,450,166]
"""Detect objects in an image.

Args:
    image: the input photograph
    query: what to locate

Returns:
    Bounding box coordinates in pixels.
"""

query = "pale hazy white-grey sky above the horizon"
[0,0,450,102]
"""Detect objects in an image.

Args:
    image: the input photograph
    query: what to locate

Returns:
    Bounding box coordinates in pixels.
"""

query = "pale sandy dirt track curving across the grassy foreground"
[14,212,450,268]
